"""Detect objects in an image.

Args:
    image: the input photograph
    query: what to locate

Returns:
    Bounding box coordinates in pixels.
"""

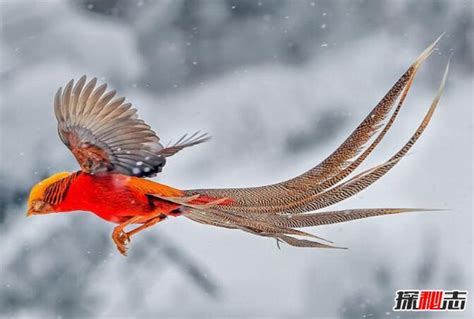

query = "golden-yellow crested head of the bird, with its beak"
[26,172,70,216]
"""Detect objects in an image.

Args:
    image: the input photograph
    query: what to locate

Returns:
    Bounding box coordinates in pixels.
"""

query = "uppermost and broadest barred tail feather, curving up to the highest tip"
[187,36,441,213]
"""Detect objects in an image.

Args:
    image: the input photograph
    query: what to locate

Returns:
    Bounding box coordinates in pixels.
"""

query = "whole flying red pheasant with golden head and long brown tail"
[27,37,449,255]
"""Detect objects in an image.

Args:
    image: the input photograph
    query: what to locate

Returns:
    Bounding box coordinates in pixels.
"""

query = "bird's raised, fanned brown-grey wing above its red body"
[54,76,207,177]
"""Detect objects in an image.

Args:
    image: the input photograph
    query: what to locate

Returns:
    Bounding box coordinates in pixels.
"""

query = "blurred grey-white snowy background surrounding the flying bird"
[0,0,474,318]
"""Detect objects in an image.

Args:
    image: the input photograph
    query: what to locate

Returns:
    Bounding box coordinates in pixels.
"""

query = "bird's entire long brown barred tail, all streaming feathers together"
[167,38,449,247]
